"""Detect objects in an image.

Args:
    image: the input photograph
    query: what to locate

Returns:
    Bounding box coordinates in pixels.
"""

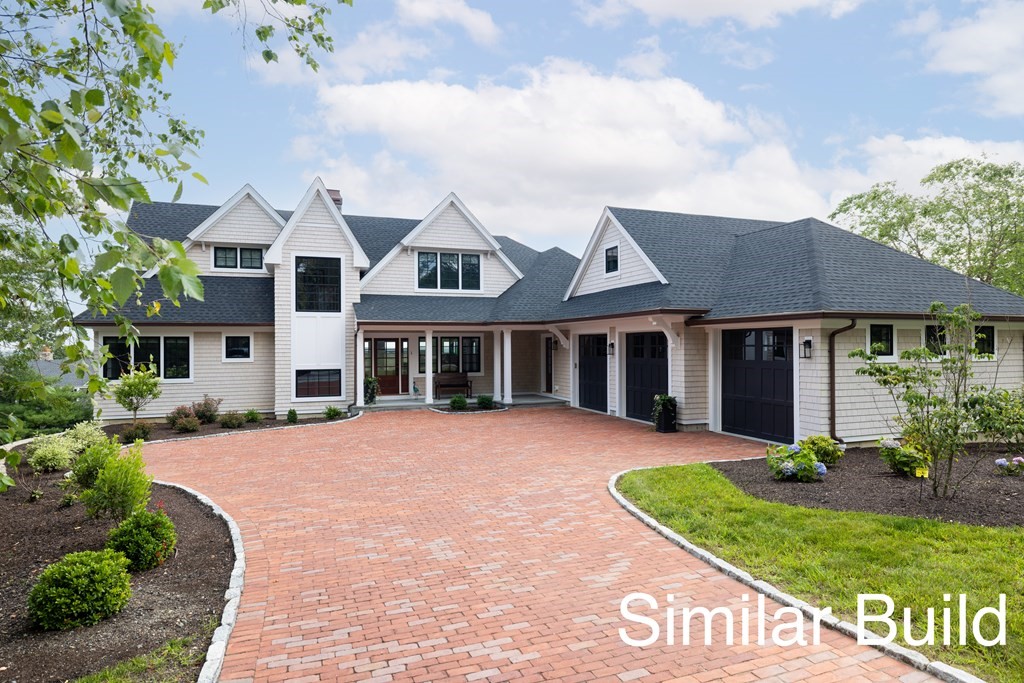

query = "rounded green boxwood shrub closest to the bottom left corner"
[29,550,131,631]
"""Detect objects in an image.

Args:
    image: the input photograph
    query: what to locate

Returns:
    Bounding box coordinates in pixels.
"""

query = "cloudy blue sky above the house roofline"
[146,0,1024,254]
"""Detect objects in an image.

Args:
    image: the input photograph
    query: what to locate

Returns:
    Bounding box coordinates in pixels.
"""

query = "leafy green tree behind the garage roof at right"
[830,158,1024,295]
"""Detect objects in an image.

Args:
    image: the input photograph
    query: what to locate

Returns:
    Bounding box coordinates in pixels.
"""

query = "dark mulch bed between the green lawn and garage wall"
[713,446,1024,526]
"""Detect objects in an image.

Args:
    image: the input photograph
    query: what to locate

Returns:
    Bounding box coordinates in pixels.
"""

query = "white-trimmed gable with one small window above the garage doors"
[565,210,666,298]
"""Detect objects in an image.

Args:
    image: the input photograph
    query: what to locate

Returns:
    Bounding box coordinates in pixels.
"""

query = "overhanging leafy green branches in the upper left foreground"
[0,0,351,438]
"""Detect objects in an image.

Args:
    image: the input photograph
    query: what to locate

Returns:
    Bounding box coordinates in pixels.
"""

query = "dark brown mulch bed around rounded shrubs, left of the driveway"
[0,458,234,683]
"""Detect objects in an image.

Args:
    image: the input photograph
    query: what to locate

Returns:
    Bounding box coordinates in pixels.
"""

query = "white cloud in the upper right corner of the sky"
[925,0,1024,116]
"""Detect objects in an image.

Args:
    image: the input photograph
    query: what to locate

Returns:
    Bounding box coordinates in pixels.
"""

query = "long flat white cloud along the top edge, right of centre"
[577,0,862,28]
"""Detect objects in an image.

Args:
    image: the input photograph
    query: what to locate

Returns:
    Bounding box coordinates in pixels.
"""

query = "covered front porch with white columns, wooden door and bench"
[355,323,569,409]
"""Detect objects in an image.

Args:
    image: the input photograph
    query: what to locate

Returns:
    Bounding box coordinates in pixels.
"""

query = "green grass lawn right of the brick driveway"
[618,465,1024,682]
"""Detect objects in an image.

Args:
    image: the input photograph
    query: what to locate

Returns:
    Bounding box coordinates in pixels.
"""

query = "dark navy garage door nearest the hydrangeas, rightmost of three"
[722,328,793,443]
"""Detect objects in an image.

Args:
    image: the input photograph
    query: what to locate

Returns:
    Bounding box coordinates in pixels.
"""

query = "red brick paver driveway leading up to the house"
[145,408,937,682]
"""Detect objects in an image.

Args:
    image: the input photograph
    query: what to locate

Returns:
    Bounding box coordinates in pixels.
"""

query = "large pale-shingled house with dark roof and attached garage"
[79,179,1024,442]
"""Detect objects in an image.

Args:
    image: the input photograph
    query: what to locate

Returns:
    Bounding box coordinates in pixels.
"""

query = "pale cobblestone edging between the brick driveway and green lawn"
[608,466,985,683]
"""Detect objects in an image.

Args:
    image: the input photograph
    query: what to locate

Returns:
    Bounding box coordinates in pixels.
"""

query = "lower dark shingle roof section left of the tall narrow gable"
[75,275,273,326]
